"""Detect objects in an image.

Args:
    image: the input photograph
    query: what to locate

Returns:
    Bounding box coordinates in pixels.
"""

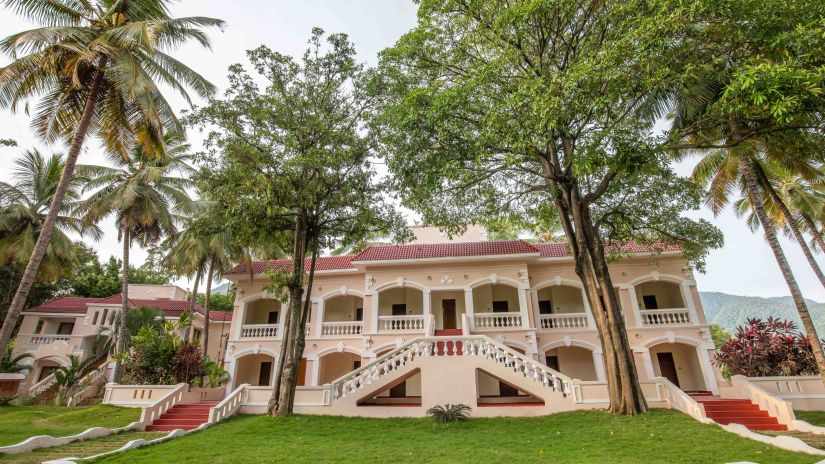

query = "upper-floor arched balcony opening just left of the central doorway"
[378,287,424,332]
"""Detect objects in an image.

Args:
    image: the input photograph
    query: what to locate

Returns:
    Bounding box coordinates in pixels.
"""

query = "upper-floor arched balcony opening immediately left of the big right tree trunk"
[536,285,588,329]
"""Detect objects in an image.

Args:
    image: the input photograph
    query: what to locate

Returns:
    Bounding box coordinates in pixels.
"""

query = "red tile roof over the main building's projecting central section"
[353,240,538,262]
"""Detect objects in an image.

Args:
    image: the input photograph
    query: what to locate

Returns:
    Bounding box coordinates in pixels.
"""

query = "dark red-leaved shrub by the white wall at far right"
[714,317,817,377]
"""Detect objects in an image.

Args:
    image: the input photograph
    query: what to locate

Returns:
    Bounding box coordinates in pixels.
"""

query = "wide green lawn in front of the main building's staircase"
[91,410,821,464]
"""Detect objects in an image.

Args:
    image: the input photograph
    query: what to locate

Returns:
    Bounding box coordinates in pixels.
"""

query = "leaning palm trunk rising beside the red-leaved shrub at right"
[739,155,825,384]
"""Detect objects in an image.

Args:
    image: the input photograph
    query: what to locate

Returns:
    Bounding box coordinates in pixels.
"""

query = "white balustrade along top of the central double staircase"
[331,335,571,399]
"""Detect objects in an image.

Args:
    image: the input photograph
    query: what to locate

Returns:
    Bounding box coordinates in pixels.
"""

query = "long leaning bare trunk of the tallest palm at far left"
[0,66,106,348]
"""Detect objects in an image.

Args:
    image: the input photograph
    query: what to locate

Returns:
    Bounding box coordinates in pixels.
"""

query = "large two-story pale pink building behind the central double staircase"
[225,228,721,412]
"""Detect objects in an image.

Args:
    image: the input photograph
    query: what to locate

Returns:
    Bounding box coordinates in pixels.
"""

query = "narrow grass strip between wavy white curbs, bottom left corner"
[0,432,167,464]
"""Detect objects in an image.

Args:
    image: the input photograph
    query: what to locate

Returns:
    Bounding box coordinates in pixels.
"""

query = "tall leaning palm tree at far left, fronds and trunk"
[0,0,223,354]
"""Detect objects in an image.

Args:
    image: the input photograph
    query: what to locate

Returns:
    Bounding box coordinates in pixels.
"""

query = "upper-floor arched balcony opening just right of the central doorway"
[473,284,522,330]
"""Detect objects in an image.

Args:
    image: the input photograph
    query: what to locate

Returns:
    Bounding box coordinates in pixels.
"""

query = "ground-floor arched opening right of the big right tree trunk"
[650,342,708,392]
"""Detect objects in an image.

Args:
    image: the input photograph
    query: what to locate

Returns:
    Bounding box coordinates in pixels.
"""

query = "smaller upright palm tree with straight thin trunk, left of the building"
[78,135,192,378]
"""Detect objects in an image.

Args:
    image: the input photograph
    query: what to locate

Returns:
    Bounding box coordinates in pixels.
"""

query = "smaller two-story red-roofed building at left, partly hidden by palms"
[14,284,231,392]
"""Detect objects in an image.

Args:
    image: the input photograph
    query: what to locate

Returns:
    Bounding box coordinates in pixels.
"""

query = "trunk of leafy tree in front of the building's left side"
[267,209,307,416]
